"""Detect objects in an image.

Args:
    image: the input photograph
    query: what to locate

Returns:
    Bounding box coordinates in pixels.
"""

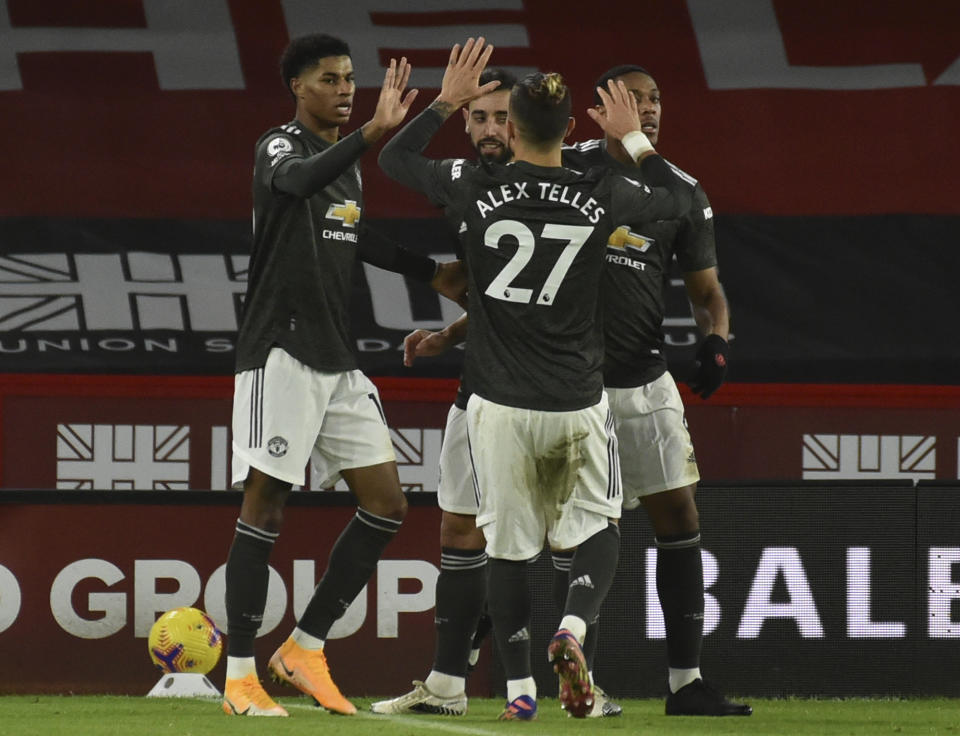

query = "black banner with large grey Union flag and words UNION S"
[0,215,960,384]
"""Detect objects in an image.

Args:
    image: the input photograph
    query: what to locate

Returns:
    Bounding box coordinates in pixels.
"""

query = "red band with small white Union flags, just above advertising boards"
[0,374,960,492]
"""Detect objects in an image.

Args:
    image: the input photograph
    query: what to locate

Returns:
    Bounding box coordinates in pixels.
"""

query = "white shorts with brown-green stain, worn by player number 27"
[467,394,621,560]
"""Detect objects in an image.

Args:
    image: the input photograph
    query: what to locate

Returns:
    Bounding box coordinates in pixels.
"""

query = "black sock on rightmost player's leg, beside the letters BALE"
[656,531,703,669]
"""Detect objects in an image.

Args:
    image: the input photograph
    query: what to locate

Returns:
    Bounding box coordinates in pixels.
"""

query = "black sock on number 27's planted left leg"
[487,559,531,680]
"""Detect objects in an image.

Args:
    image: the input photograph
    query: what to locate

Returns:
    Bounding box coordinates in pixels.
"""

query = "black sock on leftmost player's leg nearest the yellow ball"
[225,519,279,657]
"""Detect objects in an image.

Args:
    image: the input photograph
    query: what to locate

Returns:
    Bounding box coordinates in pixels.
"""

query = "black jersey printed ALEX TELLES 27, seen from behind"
[380,109,689,411]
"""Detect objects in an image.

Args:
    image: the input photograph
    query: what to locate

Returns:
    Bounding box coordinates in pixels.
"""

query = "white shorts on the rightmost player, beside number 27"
[606,373,700,509]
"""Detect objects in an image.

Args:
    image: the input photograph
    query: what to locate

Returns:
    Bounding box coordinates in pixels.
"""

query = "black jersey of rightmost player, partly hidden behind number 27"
[563,140,717,388]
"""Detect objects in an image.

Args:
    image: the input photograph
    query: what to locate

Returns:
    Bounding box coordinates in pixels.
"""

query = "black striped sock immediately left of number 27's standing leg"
[433,547,487,677]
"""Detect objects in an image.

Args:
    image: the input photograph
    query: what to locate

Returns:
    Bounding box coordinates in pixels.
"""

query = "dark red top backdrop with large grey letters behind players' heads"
[0,0,960,219]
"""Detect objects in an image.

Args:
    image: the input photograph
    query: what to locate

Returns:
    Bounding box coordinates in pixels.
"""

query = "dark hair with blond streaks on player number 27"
[510,72,572,144]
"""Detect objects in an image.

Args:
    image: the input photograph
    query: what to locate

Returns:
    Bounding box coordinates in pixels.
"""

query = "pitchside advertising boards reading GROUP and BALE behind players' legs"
[0,481,960,697]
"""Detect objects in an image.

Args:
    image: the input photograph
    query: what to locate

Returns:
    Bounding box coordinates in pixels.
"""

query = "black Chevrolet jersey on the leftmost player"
[237,122,366,372]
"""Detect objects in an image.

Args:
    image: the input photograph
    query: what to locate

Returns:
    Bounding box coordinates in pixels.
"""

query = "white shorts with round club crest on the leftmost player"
[233,348,396,488]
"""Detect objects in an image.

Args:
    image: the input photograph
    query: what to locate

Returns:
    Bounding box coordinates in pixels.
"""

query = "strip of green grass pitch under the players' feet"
[0,695,960,736]
